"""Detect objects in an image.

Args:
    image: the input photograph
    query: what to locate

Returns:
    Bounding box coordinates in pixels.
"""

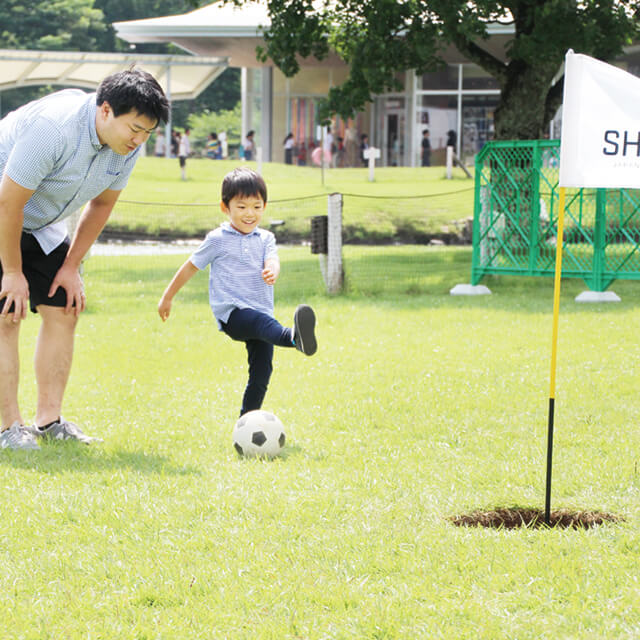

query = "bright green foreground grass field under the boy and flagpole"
[5,247,640,640]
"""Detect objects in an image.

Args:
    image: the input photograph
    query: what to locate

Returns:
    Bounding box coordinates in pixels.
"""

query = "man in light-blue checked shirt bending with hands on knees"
[0,69,169,449]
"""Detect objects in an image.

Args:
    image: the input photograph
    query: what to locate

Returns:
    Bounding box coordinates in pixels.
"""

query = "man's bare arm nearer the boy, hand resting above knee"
[49,189,120,315]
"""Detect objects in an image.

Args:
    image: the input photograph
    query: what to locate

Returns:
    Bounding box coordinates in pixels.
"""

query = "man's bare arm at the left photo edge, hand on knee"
[0,175,33,322]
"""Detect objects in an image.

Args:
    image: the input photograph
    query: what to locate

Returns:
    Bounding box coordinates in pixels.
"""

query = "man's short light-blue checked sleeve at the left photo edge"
[4,118,64,190]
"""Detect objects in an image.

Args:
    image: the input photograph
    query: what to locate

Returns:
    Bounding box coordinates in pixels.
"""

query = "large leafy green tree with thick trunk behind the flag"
[242,0,640,139]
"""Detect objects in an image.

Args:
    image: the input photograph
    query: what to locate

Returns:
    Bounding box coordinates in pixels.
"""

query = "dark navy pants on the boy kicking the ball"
[221,309,293,415]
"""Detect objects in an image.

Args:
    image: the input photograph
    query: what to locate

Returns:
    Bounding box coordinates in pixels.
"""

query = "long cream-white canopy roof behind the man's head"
[0,49,228,100]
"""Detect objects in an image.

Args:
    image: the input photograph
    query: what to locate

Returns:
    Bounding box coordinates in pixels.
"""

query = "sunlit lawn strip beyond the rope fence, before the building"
[107,157,473,241]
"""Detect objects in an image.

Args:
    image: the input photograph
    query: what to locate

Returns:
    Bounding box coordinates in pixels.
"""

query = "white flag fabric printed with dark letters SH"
[560,51,640,189]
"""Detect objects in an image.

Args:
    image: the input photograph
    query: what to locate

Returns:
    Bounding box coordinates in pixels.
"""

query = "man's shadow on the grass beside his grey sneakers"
[0,442,202,476]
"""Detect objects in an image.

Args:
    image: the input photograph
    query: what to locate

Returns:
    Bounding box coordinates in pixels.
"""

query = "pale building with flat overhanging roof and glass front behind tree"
[114,2,640,166]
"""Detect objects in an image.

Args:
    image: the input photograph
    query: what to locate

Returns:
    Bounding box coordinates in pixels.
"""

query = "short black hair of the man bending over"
[96,67,170,124]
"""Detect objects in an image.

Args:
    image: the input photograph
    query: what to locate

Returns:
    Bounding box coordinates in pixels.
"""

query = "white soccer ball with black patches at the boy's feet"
[233,409,286,458]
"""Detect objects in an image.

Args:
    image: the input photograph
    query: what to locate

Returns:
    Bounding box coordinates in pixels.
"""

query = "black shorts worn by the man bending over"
[0,231,70,313]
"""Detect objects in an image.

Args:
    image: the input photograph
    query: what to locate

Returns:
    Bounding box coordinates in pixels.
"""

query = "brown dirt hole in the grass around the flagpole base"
[447,507,624,529]
